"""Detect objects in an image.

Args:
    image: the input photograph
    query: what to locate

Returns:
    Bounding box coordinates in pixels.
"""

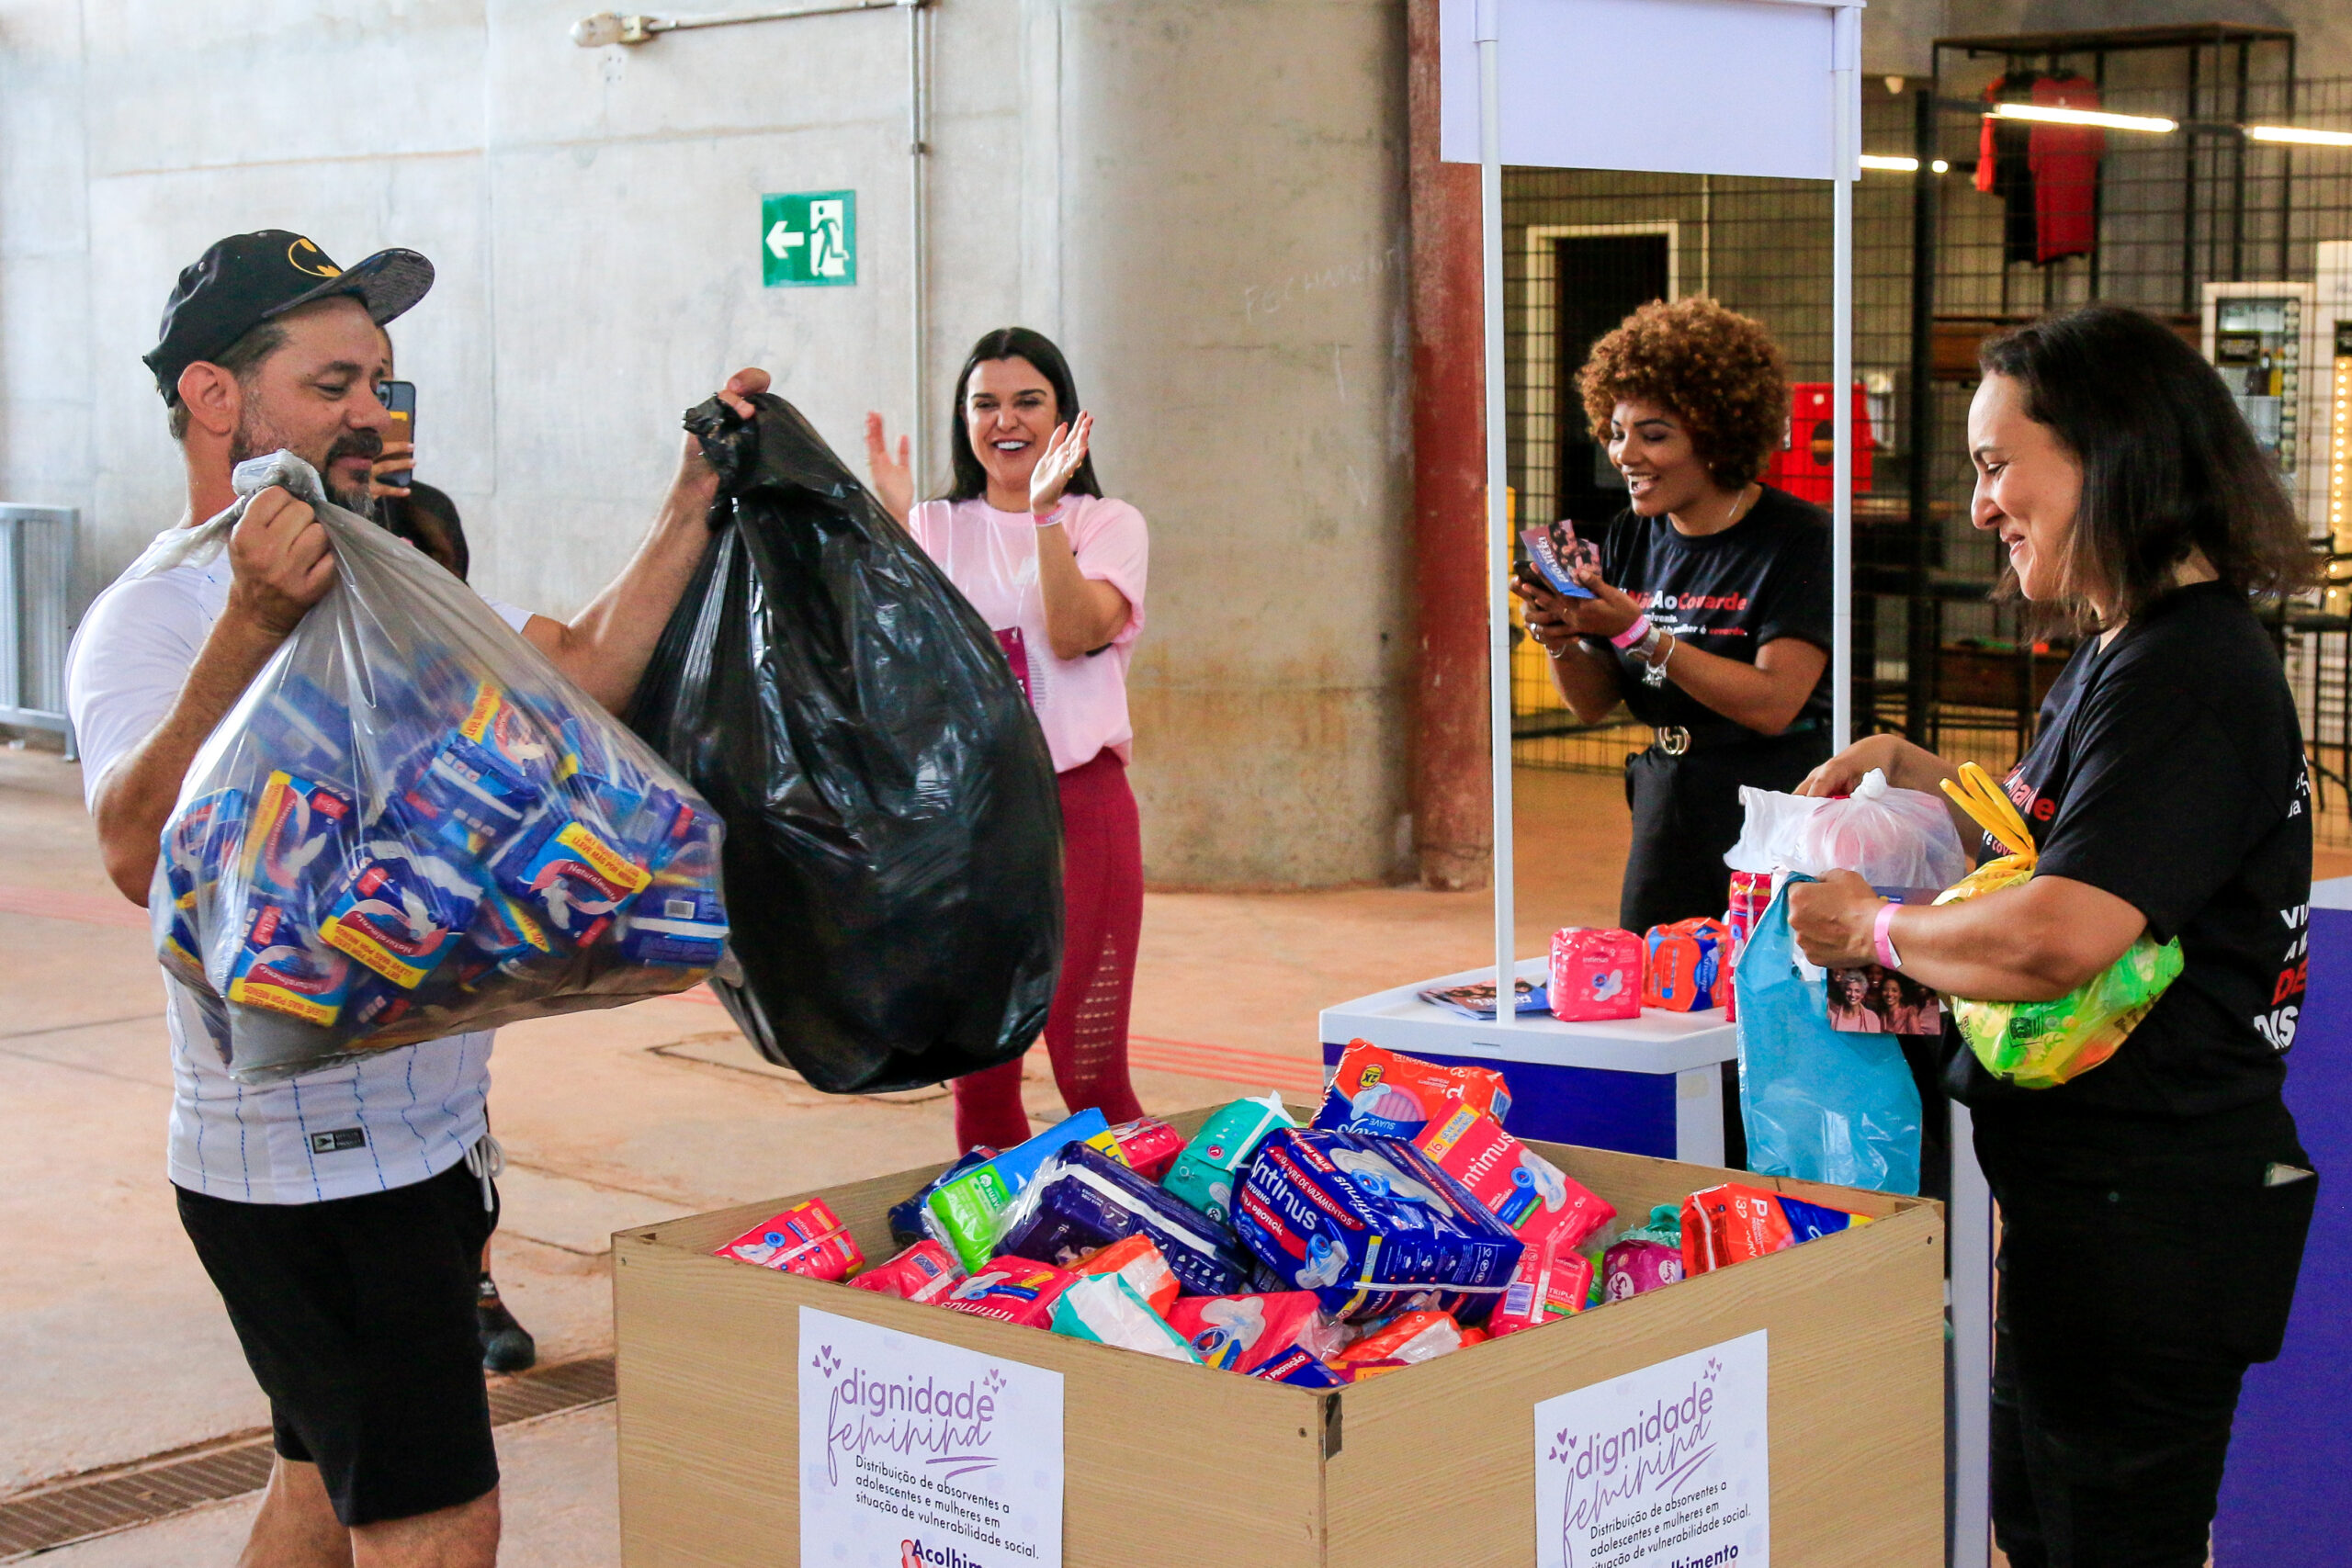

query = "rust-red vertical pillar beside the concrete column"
[1407,0,1494,891]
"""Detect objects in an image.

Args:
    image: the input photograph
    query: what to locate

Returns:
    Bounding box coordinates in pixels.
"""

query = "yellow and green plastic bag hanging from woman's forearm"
[1936,761,2180,1089]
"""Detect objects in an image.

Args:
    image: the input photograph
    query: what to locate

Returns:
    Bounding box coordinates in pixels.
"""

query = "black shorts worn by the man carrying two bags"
[179,1161,499,1526]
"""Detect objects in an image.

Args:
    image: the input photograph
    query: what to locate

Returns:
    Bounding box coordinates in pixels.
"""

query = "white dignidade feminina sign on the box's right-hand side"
[1536,1328,1771,1568]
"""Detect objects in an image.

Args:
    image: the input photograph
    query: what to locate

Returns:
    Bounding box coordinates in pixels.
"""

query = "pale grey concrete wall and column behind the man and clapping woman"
[0,0,1407,884]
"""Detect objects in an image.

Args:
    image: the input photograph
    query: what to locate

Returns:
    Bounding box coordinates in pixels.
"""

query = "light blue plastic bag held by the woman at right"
[1738,877,1919,1192]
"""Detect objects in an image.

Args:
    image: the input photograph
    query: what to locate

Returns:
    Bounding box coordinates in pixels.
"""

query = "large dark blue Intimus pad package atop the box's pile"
[1235,1128,1524,1321]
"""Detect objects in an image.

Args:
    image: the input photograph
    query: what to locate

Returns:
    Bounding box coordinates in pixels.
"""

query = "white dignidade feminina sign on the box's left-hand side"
[799,1307,1061,1568]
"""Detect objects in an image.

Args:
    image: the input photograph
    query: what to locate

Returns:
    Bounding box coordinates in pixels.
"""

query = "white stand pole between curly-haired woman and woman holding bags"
[1830,5,1863,752]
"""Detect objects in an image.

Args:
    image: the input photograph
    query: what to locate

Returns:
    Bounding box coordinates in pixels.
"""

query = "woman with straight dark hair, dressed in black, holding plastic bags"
[1790,306,2319,1568]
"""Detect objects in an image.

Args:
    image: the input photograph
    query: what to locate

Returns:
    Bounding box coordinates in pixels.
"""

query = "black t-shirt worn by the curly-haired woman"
[1595,484,1830,728]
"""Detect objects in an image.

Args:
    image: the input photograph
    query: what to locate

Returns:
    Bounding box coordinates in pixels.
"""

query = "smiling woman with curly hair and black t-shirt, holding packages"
[1517,299,1830,931]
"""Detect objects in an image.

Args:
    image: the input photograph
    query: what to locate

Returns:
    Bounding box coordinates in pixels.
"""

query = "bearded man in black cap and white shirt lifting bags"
[68,231,767,1568]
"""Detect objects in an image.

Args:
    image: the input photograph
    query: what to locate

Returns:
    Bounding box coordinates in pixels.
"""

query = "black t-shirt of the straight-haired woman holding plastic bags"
[1948,583,2312,1126]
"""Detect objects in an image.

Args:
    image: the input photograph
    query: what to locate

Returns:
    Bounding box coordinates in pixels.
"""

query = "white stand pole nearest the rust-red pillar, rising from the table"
[1477,0,1520,1027]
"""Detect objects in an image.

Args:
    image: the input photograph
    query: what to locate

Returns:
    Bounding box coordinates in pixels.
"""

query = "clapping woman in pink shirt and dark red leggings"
[865,327,1150,1149]
